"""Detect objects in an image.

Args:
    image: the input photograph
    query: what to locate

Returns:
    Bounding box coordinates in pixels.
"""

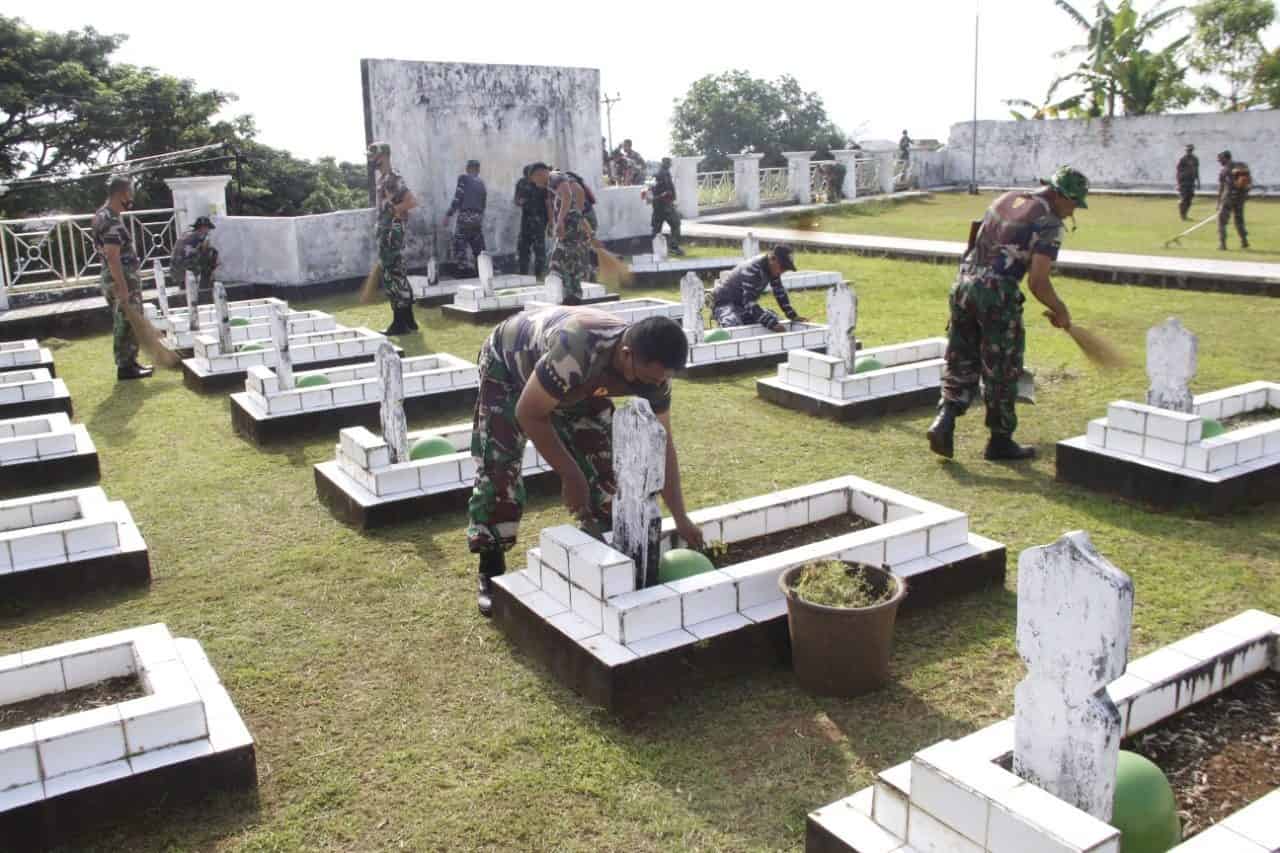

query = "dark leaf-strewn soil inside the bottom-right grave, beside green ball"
[1124,674,1280,839]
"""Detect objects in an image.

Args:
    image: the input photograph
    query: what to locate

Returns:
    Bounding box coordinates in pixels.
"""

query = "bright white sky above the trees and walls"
[0,0,1276,160]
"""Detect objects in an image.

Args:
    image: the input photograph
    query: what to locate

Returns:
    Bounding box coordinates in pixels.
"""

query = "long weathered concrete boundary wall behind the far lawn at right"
[946,110,1280,188]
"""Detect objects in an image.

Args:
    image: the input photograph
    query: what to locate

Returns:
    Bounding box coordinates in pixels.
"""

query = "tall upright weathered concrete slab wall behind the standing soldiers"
[361,59,624,265]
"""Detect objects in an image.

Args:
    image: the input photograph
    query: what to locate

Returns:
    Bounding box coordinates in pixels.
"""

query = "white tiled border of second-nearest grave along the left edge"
[0,485,147,578]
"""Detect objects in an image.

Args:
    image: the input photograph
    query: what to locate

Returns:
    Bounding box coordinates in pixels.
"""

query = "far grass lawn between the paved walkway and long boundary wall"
[769,192,1280,263]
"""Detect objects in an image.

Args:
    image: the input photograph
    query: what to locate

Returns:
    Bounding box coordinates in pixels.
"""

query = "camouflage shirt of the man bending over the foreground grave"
[485,306,671,412]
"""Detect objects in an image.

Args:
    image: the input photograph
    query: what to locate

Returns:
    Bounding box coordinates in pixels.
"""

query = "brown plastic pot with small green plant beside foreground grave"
[778,562,906,697]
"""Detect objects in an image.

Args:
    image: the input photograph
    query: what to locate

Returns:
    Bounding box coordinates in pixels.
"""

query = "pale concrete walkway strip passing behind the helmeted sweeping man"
[684,220,1280,296]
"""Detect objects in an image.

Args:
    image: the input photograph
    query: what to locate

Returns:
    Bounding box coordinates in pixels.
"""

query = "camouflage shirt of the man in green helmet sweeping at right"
[961,190,1062,283]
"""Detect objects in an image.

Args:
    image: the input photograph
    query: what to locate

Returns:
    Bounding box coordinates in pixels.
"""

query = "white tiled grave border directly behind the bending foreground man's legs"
[316,423,552,506]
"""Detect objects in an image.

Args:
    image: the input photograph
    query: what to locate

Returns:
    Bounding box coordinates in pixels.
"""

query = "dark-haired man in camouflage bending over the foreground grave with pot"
[467,306,703,616]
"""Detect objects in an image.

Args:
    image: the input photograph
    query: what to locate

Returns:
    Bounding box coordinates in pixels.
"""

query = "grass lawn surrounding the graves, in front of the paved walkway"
[0,253,1280,852]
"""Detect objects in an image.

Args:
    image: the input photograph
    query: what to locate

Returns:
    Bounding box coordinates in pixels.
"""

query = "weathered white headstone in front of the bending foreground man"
[613,397,667,588]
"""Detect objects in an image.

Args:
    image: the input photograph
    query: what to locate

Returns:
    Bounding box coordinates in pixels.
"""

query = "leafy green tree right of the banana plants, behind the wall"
[1190,0,1276,110]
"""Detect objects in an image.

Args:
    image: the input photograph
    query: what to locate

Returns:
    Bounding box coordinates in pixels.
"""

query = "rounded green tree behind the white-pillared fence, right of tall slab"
[671,70,845,169]
